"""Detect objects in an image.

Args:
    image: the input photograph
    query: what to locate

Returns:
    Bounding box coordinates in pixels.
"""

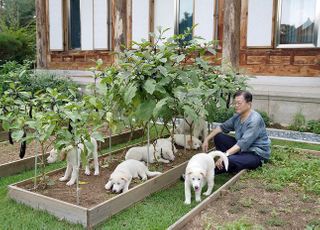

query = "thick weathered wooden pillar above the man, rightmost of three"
[222,0,241,70]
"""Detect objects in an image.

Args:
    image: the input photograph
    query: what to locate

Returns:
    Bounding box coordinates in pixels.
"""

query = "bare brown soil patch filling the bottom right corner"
[184,179,320,229]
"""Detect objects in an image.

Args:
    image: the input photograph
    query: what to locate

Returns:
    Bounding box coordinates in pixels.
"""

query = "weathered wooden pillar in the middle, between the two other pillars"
[113,0,127,52]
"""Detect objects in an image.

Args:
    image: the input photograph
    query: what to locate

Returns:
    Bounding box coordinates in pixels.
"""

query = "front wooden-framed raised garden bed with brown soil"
[9,139,205,227]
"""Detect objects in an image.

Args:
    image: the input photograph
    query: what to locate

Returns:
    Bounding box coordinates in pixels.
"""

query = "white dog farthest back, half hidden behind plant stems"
[176,117,208,140]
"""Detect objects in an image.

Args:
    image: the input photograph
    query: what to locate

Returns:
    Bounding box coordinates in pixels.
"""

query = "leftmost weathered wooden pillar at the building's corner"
[35,0,48,69]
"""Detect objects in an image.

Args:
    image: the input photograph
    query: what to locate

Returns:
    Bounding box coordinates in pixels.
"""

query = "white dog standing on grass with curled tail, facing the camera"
[184,151,229,204]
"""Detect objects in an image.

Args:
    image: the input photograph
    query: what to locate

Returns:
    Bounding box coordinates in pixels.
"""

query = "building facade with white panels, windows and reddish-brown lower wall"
[37,0,320,76]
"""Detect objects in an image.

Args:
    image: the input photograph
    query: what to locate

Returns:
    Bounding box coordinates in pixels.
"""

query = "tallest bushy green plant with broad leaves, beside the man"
[101,28,246,143]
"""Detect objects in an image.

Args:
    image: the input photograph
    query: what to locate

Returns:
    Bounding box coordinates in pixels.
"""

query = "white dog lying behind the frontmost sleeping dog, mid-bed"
[125,139,177,163]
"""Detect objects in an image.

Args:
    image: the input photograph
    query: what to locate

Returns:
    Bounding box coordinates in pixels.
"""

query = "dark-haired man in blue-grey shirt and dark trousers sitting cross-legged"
[202,91,271,174]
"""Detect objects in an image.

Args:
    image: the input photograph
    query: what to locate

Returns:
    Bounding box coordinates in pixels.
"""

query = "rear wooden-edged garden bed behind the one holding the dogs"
[0,129,143,177]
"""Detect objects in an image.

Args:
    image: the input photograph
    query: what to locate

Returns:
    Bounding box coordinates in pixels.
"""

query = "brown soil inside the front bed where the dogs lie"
[21,146,208,208]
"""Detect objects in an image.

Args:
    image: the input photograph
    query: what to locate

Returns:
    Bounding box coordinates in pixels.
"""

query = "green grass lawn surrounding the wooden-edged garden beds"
[0,136,320,229]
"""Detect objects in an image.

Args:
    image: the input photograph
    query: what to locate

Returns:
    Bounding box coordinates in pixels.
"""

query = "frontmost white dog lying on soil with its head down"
[104,159,162,193]
